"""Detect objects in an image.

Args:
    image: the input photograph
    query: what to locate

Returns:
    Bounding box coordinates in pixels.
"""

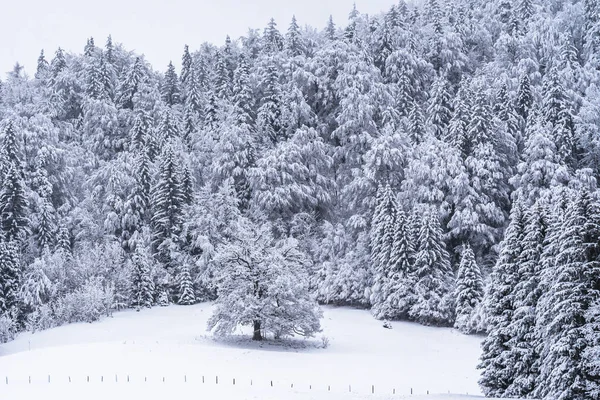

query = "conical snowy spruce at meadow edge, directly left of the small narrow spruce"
[410,210,454,325]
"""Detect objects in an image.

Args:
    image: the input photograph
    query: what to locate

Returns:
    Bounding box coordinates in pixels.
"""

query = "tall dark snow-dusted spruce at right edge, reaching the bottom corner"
[535,191,600,399]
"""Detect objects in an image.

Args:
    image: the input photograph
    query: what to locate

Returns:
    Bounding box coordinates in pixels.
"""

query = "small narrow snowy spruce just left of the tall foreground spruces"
[454,244,483,333]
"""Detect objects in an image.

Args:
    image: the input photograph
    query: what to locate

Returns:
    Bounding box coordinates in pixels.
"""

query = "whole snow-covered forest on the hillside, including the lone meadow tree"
[0,0,600,400]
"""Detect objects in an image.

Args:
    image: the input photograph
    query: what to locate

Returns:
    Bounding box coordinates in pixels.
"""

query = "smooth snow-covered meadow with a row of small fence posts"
[0,304,488,400]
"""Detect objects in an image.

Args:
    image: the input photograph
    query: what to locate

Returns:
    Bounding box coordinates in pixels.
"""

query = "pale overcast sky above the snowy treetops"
[0,0,396,79]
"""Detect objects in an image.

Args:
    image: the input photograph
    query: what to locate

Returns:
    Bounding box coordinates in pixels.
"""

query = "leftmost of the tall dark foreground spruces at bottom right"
[478,202,525,397]
